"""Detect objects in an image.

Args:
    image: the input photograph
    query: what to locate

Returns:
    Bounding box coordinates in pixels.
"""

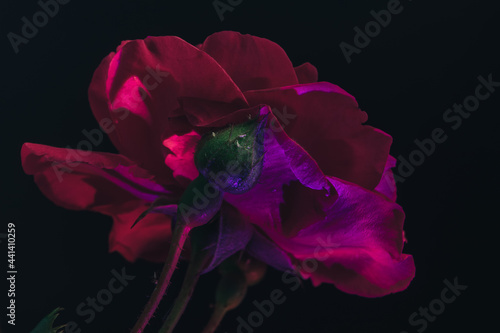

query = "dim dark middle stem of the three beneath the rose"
[159,249,207,333]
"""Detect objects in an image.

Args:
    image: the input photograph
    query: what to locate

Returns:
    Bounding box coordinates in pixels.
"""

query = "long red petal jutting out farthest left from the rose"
[21,143,178,210]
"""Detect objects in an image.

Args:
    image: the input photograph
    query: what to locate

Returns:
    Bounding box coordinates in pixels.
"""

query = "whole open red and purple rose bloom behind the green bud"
[22,31,415,297]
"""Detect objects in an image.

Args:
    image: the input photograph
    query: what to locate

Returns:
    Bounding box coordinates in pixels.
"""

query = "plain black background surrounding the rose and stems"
[0,0,500,333]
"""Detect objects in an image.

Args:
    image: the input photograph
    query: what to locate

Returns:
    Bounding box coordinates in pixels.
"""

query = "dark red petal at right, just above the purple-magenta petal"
[245,82,392,189]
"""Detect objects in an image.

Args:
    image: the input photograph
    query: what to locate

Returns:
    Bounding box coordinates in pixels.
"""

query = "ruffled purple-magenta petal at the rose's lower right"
[271,177,415,297]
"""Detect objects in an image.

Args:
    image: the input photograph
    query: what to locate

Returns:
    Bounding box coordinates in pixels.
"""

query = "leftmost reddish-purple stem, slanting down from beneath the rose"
[132,223,191,333]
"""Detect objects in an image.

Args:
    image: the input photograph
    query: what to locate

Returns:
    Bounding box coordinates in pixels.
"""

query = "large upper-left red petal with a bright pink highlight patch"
[89,36,246,175]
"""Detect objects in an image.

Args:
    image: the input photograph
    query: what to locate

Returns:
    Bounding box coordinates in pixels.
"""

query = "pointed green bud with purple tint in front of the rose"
[194,116,267,194]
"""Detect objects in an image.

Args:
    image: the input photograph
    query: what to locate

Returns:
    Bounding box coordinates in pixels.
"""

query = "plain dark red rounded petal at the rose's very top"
[201,31,298,91]
